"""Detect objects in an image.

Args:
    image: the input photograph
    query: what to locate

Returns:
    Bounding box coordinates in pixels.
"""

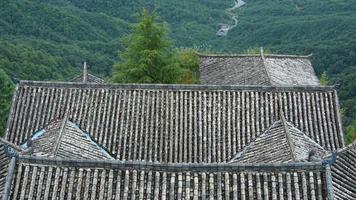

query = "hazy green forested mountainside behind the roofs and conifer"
[0,0,356,141]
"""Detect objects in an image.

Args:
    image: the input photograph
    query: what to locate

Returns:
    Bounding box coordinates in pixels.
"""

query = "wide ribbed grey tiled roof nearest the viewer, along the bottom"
[6,157,328,200]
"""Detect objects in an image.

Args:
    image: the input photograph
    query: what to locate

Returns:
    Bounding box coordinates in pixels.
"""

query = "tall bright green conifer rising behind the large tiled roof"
[112,9,198,83]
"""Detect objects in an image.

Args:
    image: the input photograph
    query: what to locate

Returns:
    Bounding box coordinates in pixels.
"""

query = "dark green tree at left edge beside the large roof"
[0,69,14,136]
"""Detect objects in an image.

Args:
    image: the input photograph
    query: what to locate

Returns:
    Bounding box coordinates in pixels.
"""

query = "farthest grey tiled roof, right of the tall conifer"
[199,54,320,86]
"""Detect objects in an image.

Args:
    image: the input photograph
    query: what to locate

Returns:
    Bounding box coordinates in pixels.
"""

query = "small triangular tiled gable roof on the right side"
[231,115,327,163]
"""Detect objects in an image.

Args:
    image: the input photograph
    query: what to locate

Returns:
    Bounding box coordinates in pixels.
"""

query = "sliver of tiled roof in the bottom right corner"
[331,143,356,200]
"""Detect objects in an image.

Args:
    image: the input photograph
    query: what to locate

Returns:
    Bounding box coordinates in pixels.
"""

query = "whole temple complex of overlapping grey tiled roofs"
[0,52,356,200]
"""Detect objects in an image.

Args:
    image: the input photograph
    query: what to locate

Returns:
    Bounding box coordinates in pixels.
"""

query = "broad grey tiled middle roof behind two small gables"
[6,82,344,163]
